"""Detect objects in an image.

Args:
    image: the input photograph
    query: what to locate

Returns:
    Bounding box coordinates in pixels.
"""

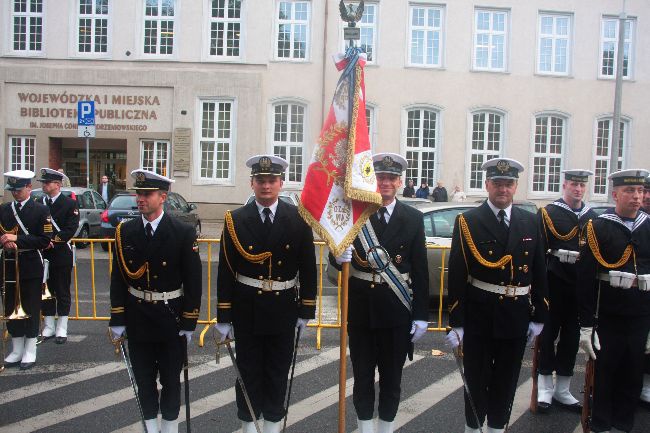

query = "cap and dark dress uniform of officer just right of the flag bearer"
[447,158,549,433]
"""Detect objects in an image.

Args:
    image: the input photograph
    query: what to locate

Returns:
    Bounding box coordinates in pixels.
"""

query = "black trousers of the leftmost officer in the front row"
[128,337,185,421]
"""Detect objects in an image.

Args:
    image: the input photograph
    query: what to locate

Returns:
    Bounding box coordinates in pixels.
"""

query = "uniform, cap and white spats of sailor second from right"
[537,169,598,413]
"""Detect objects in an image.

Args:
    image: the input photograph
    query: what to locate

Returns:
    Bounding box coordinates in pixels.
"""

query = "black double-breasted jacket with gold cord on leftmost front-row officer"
[110,213,201,341]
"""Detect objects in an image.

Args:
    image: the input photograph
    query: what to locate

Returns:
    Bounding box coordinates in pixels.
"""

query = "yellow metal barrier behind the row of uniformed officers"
[70,238,449,349]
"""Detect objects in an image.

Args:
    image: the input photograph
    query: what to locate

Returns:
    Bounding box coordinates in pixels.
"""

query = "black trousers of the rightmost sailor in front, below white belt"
[591,314,650,432]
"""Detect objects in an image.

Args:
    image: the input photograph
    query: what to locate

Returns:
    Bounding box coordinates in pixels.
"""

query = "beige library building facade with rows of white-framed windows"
[0,0,650,218]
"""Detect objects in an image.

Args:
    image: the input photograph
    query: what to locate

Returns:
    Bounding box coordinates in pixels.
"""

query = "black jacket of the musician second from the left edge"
[43,194,79,266]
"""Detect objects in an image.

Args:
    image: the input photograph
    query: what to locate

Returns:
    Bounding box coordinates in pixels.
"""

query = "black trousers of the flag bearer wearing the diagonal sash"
[348,325,411,421]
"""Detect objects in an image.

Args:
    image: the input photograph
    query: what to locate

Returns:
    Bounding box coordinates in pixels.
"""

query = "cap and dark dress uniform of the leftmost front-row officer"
[110,170,202,433]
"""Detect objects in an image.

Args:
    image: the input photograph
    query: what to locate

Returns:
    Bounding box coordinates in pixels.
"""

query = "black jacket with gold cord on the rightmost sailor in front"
[577,210,650,327]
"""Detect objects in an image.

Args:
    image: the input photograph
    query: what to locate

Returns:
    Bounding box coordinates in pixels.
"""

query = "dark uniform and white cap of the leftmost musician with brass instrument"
[0,170,52,370]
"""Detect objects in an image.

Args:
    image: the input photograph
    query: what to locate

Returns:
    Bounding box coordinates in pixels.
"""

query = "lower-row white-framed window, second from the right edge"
[528,111,569,199]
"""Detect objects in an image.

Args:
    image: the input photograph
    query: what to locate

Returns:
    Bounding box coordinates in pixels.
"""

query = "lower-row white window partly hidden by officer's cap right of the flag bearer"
[465,108,508,194]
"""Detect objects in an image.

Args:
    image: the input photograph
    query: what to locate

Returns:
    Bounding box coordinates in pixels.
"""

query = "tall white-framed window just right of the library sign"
[199,101,235,182]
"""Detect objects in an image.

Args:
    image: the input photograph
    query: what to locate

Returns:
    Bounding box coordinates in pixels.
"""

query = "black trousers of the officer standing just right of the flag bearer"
[463,334,526,429]
